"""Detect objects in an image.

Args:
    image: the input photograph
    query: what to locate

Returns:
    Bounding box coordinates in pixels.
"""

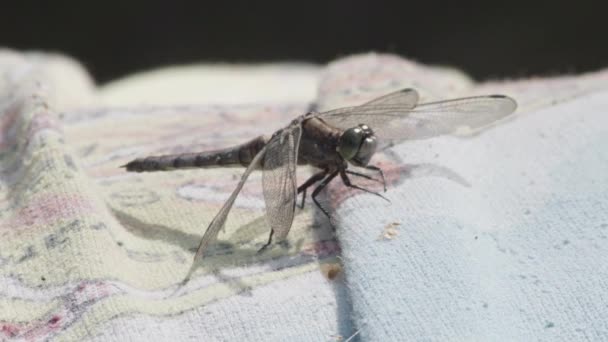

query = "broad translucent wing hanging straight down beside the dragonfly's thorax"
[262,124,302,240]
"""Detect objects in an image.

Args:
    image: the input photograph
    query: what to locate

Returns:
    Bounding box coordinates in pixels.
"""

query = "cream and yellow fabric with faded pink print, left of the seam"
[0,51,352,341]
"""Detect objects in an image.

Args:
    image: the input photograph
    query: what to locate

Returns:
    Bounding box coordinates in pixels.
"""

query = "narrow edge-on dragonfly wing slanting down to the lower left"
[194,148,266,260]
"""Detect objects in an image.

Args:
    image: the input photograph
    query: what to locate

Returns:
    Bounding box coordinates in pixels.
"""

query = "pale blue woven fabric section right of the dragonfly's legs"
[337,92,608,341]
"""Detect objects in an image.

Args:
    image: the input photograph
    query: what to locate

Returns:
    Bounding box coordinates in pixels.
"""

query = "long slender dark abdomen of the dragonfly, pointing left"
[123,136,268,172]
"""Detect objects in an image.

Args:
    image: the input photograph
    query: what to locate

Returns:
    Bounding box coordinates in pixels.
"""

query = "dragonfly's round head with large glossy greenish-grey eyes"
[338,124,378,166]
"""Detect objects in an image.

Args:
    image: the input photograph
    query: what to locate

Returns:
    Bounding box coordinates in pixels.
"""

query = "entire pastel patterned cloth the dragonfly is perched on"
[0,50,608,341]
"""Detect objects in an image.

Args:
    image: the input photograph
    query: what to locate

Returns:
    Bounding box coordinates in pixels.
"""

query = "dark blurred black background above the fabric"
[0,0,608,82]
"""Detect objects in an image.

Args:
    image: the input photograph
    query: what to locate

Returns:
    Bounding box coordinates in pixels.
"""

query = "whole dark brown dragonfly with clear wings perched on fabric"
[123,88,517,261]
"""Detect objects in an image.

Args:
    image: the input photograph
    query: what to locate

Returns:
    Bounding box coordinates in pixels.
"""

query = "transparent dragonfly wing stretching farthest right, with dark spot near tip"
[317,95,517,141]
